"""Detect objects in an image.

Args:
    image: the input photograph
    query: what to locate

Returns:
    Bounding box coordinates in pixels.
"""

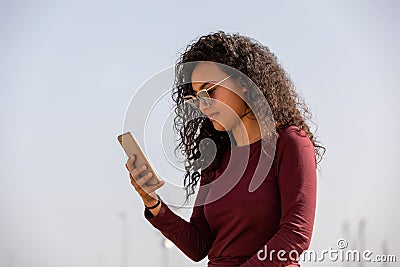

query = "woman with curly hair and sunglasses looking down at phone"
[126,31,325,266]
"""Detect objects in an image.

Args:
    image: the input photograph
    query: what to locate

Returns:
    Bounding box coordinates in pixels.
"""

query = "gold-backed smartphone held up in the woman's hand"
[118,132,160,185]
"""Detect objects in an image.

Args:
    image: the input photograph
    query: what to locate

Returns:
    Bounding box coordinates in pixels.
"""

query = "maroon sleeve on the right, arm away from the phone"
[241,131,316,267]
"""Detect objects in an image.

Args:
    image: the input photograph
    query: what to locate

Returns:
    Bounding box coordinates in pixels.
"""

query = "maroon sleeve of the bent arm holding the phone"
[145,172,215,262]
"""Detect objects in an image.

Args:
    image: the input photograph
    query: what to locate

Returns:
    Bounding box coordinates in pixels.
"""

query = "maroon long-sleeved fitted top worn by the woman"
[145,126,316,267]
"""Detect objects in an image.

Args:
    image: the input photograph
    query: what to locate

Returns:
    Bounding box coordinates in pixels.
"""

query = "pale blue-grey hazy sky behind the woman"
[0,0,400,267]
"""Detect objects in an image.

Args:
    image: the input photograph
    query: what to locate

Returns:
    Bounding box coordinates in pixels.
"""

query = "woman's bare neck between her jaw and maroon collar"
[232,112,261,146]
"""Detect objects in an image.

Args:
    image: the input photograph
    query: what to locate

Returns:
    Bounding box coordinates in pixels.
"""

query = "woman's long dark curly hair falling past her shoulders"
[172,31,325,201]
